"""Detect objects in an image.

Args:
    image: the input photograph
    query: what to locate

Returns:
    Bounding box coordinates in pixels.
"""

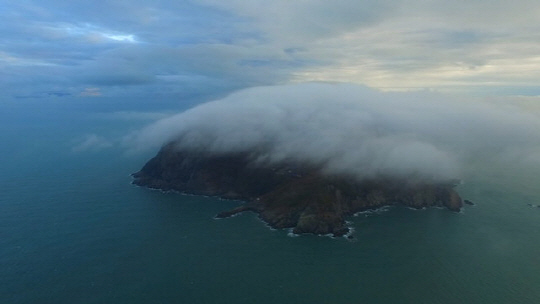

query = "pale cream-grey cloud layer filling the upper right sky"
[195,0,540,93]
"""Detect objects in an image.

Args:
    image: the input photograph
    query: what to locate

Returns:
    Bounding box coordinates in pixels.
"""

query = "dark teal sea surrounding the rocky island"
[0,101,540,304]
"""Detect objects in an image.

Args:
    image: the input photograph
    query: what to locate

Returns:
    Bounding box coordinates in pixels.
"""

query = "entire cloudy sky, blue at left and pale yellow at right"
[0,0,540,104]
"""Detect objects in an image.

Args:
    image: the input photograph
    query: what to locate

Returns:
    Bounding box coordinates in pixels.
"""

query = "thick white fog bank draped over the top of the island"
[127,83,540,180]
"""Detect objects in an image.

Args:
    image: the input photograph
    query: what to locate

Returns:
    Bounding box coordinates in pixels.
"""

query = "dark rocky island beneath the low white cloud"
[132,141,463,237]
